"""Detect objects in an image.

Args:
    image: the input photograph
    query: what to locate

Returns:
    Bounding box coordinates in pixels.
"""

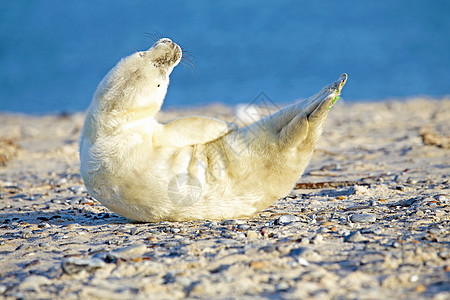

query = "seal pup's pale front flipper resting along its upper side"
[154,116,237,147]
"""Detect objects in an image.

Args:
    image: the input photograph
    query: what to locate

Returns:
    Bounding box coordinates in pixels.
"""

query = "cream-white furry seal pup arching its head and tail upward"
[80,38,347,222]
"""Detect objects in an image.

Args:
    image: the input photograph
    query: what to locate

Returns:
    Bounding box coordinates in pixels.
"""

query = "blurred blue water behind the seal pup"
[0,0,450,114]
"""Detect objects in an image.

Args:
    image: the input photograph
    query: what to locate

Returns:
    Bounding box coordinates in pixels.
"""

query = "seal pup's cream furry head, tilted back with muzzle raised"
[94,38,182,118]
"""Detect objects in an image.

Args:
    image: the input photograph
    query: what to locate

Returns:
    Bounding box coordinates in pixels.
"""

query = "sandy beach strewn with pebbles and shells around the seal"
[0,98,450,299]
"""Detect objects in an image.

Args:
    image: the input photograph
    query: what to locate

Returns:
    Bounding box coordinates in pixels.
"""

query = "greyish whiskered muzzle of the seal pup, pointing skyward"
[147,38,183,68]
